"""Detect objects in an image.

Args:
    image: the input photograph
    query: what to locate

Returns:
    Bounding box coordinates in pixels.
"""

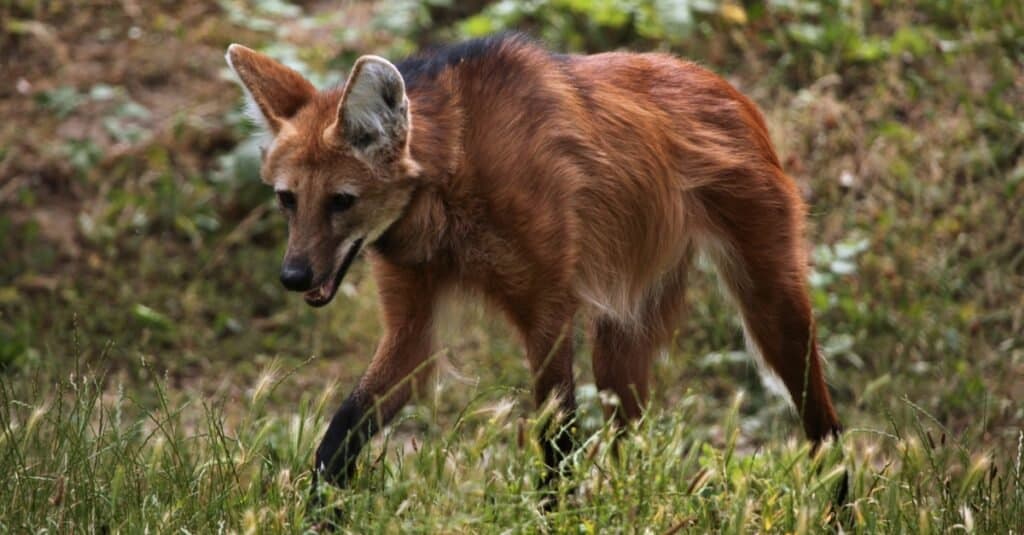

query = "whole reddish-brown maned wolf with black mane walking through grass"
[227,34,841,491]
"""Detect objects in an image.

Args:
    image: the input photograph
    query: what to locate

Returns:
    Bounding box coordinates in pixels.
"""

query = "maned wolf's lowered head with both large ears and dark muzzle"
[226,44,419,306]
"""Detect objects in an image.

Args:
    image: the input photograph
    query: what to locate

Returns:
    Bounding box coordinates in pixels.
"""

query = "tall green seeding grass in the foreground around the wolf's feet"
[0,340,1024,533]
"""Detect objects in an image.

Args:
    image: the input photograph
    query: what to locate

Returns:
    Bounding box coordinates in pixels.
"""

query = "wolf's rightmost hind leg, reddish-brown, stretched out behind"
[705,176,842,444]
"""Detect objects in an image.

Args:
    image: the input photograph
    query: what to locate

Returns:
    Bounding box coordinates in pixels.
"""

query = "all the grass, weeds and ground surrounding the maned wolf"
[0,0,1024,533]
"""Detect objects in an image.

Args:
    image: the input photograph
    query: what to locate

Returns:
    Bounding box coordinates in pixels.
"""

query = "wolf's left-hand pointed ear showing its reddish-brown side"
[224,44,316,134]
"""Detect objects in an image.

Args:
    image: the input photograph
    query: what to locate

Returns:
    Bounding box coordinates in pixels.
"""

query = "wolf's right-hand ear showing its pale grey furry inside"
[329,55,410,161]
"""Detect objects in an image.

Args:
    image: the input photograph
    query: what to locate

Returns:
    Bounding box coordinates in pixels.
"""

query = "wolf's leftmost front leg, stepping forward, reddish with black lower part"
[314,261,436,487]
